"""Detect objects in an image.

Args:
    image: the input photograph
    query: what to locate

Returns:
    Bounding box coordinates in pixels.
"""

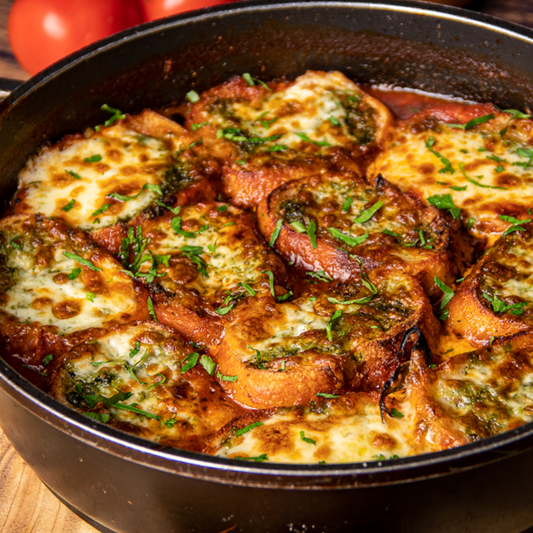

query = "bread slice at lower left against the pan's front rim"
[48,322,244,451]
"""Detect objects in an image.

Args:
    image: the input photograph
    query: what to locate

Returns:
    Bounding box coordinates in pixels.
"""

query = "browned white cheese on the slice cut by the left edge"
[0,213,138,335]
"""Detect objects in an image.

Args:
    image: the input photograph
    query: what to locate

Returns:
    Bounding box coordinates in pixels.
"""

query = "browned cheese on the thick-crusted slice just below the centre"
[233,273,417,366]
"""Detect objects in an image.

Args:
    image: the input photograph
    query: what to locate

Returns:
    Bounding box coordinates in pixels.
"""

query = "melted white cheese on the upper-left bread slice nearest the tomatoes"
[15,124,171,231]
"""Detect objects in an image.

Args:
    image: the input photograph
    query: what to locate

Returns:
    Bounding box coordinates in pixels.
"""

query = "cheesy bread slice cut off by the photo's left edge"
[0,215,149,365]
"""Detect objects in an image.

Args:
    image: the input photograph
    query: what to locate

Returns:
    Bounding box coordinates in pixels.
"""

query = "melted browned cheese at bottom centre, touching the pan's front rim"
[216,394,414,464]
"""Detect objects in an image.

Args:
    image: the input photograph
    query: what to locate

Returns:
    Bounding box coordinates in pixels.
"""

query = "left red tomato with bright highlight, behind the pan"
[7,0,143,74]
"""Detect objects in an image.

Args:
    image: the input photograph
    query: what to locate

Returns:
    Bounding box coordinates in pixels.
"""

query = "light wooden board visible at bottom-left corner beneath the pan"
[0,429,98,533]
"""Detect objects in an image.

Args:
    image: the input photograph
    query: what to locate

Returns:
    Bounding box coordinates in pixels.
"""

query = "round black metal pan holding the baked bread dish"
[0,0,533,533]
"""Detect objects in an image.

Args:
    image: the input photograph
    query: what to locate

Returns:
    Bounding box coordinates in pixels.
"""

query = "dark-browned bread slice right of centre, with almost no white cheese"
[258,174,472,300]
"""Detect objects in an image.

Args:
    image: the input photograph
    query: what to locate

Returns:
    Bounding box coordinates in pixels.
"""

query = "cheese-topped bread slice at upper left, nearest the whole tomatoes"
[12,110,220,253]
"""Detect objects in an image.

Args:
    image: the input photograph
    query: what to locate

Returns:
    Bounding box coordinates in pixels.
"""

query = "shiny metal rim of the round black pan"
[0,0,533,484]
